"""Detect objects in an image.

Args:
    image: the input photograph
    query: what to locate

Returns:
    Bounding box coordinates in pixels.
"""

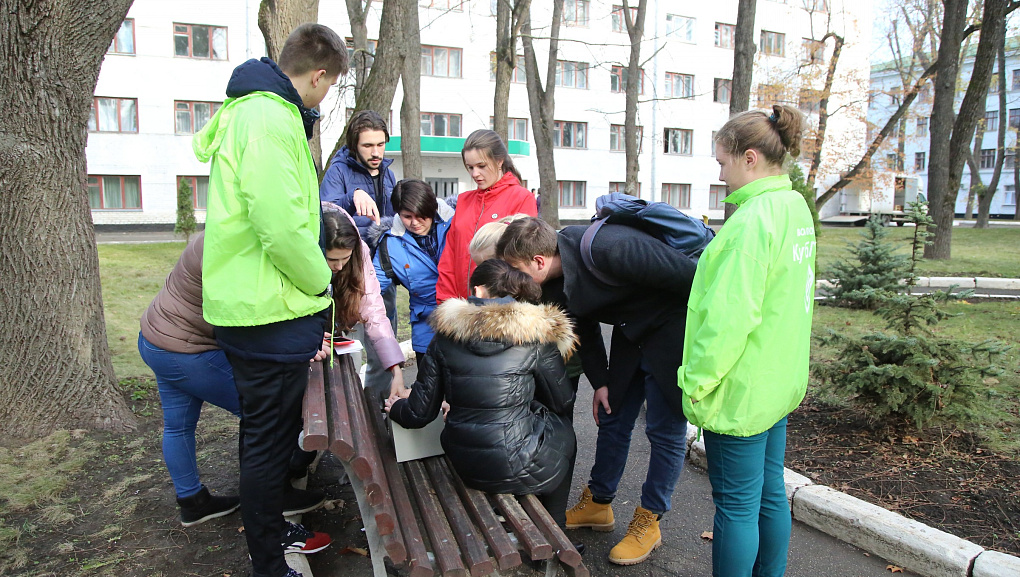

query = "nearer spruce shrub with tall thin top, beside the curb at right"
[811,203,1008,428]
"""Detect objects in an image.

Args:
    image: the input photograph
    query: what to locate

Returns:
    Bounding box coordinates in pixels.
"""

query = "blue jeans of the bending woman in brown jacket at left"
[138,333,241,499]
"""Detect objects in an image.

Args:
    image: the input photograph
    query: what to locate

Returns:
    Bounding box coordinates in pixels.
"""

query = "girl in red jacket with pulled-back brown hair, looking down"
[436,130,538,303]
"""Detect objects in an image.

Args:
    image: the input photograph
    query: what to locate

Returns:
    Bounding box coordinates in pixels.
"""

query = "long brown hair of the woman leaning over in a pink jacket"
[322,211,365,330]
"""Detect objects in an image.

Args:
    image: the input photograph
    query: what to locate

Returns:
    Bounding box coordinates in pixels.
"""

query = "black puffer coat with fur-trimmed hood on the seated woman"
[390,298,576,494]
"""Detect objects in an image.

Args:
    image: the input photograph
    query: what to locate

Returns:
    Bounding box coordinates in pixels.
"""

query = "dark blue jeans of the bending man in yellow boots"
[588,363,687,515]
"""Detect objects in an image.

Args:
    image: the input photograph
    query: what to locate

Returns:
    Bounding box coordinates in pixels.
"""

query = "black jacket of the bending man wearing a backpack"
[557,224,697,415]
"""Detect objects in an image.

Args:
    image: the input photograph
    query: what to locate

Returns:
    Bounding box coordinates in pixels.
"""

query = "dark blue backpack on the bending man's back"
[580,193,715,286]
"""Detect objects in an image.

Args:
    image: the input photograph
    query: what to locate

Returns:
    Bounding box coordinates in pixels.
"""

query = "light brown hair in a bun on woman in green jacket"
[715,104,804,167]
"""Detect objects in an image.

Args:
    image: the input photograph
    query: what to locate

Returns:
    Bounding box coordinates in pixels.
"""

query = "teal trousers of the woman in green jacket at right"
[705,417,792,577]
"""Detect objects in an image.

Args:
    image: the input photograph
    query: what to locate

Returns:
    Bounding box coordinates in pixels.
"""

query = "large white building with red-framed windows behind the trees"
[87,0,871,224]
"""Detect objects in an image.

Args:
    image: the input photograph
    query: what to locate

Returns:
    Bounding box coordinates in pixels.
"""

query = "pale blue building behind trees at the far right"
[868,38,1020,219]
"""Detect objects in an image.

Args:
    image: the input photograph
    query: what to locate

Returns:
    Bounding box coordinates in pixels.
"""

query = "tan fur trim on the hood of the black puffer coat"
[429,299,577,359]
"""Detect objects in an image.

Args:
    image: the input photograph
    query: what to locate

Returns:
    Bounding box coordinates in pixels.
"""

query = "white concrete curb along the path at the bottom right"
[687,424,1020,577]
